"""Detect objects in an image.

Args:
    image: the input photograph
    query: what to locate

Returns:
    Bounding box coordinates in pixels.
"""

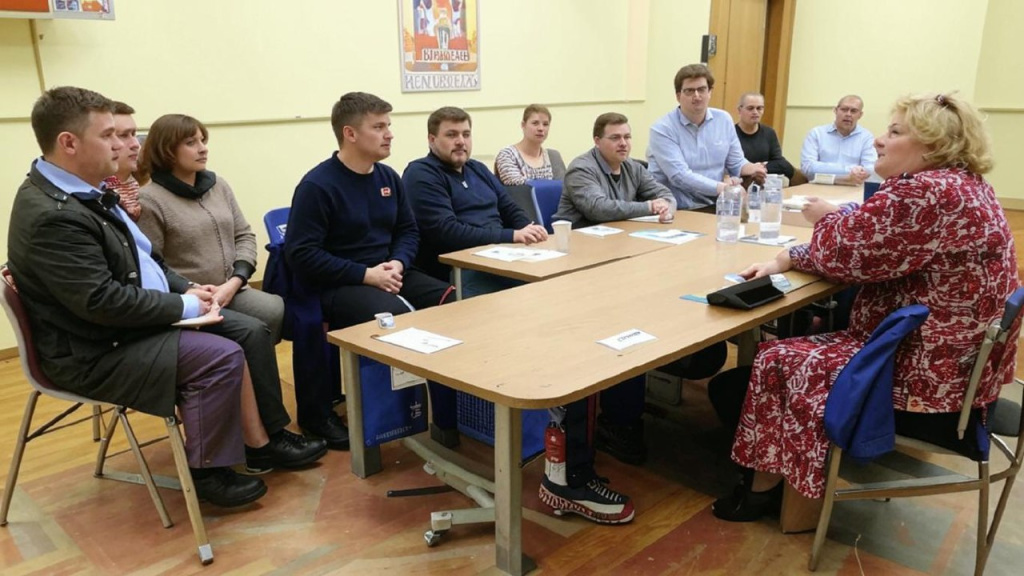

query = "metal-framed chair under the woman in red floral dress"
[808,288,1024,575]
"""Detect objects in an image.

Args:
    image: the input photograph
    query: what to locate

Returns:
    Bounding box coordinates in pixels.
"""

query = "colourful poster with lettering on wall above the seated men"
[398,0,480,92]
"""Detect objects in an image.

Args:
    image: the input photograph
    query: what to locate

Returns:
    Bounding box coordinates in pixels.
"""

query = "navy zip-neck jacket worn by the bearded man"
[401,153,529,282]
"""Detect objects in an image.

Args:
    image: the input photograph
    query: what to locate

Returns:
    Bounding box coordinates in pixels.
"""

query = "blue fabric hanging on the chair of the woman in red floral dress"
[824,304,928,459]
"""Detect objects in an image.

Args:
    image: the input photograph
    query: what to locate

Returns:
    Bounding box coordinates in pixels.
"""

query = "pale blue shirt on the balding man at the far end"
[800,124,879,179]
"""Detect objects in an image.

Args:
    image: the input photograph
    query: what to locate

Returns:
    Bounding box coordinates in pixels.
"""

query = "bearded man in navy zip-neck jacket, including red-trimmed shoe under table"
[401,107,634,524]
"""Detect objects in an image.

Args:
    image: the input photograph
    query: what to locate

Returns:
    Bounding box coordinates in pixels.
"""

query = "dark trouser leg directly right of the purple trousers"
[203,308,291,434]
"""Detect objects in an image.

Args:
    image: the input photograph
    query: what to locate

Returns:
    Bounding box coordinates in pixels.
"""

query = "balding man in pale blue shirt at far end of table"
[800,94,879,186]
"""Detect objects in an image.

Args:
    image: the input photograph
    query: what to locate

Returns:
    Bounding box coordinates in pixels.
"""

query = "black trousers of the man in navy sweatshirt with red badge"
[307,268,456,429]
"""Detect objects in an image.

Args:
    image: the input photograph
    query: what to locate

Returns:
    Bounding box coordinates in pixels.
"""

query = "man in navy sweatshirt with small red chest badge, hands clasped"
[285,92,454,450]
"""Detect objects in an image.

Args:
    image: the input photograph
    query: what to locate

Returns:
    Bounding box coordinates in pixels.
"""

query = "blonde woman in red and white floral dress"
[713,94,1019,522]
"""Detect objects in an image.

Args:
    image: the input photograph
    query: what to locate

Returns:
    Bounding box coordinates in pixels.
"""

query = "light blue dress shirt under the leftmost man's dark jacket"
[36,158,200,320]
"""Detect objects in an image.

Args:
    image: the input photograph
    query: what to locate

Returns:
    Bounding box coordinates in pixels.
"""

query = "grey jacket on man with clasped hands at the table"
[554,148,676,228]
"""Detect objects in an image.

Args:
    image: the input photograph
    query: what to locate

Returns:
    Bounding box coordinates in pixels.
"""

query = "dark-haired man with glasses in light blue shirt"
[647,64,767,211]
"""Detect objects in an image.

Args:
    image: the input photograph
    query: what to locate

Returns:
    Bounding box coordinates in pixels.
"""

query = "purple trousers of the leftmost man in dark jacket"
[176,330,246,468]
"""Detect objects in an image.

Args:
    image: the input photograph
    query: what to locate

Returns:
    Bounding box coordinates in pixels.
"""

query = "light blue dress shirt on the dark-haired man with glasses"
[647,108,748,210]
